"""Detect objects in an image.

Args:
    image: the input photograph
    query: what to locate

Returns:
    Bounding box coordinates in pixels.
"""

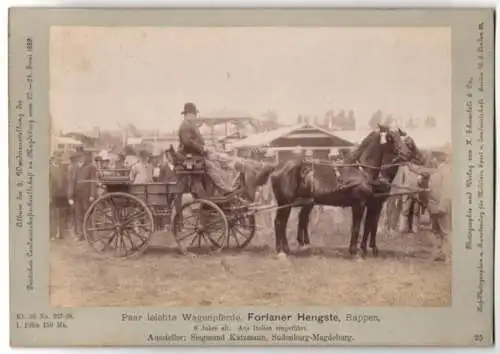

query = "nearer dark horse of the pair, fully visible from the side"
[252,126,411,254]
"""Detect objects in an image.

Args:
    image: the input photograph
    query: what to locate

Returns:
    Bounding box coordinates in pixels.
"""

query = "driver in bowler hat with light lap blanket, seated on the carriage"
[179,102,233,194]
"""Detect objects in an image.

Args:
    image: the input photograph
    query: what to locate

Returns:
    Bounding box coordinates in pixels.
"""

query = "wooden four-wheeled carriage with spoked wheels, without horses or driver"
[83,155,256,258]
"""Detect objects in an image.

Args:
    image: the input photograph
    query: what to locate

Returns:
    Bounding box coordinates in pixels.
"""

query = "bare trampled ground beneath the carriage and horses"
[50,212,451,307]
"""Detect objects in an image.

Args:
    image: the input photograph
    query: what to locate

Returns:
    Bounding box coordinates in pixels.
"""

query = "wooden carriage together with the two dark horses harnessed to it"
[84,128,438,258]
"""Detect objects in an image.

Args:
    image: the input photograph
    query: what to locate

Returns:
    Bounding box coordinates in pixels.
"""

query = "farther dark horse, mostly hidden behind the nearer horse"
[358,129,426,257]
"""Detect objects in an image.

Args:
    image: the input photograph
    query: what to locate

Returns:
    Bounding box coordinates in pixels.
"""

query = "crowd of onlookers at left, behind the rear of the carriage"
[50,148,175,240]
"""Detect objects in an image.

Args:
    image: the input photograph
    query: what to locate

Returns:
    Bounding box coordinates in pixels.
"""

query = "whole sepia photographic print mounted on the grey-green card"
[49,26,455,307]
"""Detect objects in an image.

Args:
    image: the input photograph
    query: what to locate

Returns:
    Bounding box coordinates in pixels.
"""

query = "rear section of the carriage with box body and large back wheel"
[83,168,182,258]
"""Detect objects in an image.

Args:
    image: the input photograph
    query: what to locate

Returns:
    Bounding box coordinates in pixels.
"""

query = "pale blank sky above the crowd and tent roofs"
[50,27,451,134]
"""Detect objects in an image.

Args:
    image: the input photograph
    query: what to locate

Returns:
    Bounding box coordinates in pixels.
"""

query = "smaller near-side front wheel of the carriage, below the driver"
[172,199,229,255]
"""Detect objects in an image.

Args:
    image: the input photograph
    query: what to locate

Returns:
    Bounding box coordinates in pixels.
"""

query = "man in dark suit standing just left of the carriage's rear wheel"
[68,151,97,240]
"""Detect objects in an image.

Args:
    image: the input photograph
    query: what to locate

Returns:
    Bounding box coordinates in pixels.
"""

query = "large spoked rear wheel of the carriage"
[83,192,154,258]
